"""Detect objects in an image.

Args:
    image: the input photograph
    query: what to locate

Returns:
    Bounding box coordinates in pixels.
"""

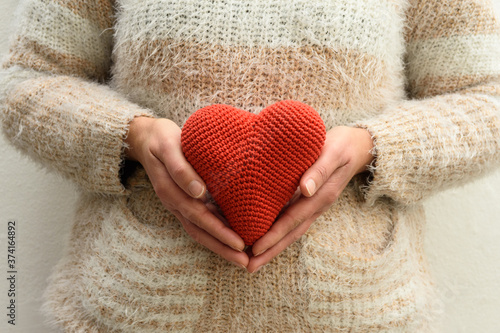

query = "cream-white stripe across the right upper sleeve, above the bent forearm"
[408,34,500,80]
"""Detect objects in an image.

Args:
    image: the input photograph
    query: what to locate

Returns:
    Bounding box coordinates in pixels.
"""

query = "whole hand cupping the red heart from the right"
[247,126,373,272]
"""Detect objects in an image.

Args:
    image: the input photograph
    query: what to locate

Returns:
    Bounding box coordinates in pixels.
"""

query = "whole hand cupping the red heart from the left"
[125,117,249,267]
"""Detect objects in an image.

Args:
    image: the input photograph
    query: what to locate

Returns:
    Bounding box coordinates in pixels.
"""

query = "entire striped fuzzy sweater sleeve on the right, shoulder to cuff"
[355,0,500,204]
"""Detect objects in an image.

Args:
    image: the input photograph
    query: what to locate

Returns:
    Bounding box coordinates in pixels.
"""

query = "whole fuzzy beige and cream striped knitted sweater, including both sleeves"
[0,0,500,332]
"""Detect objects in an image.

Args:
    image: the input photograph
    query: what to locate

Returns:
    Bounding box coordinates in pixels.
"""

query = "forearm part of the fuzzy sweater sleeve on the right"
[354,93,500,205]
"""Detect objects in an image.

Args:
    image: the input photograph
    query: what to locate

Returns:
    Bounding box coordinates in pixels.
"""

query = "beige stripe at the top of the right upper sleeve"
[406,0,499,42]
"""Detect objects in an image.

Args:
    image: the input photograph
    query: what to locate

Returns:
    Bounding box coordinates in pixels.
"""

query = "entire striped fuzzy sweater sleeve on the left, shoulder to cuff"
[0,0,153,194]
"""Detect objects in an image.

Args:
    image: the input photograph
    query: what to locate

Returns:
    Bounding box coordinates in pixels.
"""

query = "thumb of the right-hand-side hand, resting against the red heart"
[300,136,344,197]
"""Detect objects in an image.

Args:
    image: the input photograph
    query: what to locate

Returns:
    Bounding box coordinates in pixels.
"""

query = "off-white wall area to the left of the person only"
[0,0,76,333]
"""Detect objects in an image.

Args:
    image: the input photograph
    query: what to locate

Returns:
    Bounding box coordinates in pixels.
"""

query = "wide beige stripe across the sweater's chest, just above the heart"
[114,41,402,117]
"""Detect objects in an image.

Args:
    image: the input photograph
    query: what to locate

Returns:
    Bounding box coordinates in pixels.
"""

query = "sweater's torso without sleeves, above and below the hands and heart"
[63,0,438,332]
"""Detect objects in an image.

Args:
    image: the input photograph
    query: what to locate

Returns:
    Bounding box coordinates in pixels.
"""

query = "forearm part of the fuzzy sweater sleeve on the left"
[3,70,154,194]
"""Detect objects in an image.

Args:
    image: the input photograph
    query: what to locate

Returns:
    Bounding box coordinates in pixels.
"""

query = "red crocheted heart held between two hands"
[181,101,326,245]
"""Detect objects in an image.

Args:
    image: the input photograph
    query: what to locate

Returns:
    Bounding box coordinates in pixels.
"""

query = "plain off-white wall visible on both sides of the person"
[0,0,500,333]
